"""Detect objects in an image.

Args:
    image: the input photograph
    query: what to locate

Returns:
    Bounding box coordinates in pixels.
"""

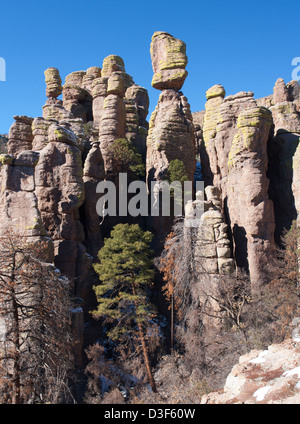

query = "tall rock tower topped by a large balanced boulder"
[146,31,196,245]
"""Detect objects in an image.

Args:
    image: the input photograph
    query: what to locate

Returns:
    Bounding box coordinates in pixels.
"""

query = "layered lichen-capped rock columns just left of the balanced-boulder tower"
[88,55,149,178]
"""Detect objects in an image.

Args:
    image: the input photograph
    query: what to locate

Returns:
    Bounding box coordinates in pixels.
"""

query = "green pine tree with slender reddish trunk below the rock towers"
[93,224,156,392]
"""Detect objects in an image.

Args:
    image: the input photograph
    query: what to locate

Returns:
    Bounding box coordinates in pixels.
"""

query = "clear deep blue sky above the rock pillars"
[0,0,300,133]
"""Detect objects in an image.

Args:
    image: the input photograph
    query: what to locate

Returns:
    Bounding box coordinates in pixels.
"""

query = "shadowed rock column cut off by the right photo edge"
[268,78,300,238]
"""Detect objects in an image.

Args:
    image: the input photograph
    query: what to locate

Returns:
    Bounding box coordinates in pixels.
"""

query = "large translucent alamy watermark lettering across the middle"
[96,173,204,227]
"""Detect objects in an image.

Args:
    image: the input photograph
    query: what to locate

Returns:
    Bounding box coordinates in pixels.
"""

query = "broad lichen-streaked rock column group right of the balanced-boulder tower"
[200,84,275,289]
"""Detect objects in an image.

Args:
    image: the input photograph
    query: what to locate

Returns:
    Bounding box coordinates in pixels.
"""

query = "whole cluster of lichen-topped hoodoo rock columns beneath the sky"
[0,31,300,403]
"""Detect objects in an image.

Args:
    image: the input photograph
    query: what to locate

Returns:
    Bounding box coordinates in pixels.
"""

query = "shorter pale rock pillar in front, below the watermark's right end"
[184,186,234,348]
